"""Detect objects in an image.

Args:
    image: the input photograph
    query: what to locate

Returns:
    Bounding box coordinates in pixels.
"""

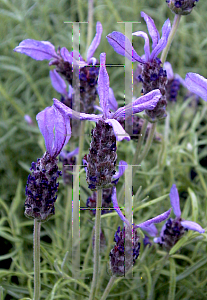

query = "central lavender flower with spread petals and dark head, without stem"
[53,53,161,190]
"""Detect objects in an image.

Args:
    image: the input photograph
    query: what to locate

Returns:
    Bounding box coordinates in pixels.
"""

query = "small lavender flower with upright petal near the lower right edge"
[154,184,205,251]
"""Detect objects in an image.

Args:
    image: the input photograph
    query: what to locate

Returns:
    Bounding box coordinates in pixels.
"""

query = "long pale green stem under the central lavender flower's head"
[89,190,102,300]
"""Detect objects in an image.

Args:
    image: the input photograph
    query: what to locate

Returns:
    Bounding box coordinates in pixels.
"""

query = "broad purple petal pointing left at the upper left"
[14,39,58,60]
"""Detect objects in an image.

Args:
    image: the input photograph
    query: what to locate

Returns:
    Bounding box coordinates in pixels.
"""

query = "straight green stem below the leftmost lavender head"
[33,219,41,300]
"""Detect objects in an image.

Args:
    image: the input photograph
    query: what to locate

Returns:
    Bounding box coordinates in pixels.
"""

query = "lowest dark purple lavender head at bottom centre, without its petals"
[109,226,140,276]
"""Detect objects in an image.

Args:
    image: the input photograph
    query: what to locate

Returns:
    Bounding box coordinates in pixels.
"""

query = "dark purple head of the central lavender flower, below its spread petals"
[86,120,117,190]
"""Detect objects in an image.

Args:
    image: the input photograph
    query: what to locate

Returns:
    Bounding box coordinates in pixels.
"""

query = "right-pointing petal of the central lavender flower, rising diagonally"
[113,89,162,119]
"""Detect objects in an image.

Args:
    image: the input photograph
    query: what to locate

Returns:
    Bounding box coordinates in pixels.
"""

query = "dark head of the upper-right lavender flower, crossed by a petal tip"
[140,58,167,120]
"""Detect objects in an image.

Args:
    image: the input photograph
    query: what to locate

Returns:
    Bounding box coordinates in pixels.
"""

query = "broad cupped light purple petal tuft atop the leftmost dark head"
[36,105,71,157]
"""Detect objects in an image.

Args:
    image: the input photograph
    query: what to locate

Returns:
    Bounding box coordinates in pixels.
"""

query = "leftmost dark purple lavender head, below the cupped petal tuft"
[25,152,61,222]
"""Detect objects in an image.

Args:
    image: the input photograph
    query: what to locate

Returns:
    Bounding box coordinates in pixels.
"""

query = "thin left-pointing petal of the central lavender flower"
[53,98,101,122]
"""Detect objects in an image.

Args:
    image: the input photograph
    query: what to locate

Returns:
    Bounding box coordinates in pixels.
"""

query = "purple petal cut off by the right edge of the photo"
[185,73,207,101]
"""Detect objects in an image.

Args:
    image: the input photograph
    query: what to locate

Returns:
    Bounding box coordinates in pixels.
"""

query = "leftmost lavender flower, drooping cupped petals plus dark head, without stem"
[25,106,71,222]
